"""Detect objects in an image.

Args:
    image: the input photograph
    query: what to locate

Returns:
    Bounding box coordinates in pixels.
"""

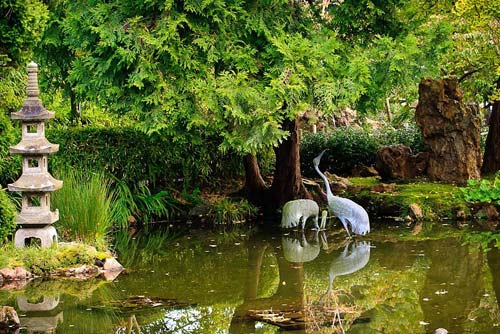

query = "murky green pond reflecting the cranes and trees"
[0,224,500,334]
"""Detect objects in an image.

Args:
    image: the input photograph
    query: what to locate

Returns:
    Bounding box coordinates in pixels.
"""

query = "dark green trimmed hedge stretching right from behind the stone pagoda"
[47,127,242,189]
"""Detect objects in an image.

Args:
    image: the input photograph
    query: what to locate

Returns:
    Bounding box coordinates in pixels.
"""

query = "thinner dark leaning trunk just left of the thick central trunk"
[243,154,266,206]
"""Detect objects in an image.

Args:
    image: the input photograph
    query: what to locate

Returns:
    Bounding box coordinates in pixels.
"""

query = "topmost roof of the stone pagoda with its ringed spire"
[11,62,55,121]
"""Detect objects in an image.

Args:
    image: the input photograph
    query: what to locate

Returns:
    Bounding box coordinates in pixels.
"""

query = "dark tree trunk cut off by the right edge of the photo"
[481,77,500,174]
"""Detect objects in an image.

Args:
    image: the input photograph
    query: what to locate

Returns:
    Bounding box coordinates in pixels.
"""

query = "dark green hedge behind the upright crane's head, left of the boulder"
[300,125,425,176]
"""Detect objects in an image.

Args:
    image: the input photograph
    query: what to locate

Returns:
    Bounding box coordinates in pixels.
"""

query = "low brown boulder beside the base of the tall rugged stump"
[375,144,428,179]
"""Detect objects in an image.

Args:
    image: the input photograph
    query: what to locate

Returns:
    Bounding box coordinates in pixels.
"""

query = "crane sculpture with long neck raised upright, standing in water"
[313,151,370,237]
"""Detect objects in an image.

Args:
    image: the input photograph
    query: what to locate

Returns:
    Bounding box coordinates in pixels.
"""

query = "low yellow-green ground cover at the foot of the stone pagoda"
[0,243,104,276]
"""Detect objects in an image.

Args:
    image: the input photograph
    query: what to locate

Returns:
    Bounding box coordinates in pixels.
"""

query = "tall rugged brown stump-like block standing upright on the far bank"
[415,79,481,183]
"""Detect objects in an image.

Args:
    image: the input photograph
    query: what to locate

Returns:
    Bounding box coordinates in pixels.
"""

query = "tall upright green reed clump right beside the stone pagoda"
[52,169,113,248]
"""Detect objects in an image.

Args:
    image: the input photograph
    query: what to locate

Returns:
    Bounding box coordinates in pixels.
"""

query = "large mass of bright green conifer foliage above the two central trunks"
[60,1,350,153]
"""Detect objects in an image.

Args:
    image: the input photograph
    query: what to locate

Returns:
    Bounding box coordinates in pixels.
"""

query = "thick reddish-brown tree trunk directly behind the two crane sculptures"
[268,119,312,209]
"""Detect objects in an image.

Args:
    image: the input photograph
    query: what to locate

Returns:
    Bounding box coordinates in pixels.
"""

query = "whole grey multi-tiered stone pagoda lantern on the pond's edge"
[9,62,62,248]
